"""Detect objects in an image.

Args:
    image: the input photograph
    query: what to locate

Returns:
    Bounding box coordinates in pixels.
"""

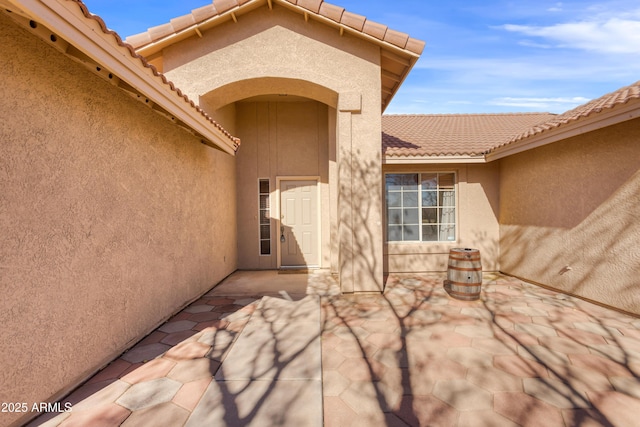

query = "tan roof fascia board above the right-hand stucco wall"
[486,100,640,162]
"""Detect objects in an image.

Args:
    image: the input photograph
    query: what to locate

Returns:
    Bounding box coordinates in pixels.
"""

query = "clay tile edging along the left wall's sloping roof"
[71,0,240,149]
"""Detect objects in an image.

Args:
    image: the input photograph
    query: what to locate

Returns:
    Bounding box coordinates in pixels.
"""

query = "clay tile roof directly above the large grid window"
[382,113,554,157]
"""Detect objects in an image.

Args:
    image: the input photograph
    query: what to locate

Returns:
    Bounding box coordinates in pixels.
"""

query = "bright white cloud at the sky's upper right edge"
[500,17,640,54]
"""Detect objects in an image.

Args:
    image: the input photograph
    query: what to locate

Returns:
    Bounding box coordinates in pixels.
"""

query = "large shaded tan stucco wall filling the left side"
[0,14,236,425]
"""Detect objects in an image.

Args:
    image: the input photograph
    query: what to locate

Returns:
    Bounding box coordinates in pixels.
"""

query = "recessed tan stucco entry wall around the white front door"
[236,101,335,269]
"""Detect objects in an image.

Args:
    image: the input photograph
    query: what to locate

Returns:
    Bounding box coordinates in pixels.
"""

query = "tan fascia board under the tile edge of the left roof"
[9,0,236,155]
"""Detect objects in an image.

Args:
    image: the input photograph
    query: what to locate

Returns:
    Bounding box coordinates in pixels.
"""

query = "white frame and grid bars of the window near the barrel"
[384,170,460,244]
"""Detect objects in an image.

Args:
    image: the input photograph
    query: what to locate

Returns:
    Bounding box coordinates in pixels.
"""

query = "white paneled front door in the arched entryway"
[279,180,319,267]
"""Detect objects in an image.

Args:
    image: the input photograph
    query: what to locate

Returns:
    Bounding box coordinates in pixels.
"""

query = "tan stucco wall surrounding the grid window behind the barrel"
[383,163,500,273]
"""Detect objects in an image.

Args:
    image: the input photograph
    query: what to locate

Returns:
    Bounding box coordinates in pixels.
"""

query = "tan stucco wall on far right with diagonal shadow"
[500,119,640,314]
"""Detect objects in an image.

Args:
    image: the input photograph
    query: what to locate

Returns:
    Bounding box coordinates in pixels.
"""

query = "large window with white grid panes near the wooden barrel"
[385,172,456,242]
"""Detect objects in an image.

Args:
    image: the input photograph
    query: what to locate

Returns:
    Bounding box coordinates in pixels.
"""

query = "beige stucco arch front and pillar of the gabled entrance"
[162,4,383,292]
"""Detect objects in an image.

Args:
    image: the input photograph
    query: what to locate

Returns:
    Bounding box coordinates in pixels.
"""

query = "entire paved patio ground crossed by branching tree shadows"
[30,272,640,427]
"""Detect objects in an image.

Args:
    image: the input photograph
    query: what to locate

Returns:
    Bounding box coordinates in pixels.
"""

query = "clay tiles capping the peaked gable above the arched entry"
[127,0,424,55]
